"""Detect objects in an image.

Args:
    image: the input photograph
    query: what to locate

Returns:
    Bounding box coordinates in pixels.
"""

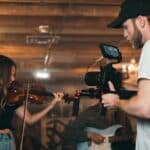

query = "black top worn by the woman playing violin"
[0,103,22,130]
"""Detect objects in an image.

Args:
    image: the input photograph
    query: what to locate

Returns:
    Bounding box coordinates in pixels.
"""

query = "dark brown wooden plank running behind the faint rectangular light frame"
[0,33,124,46]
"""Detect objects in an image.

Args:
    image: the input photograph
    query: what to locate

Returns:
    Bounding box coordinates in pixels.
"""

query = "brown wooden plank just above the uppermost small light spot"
[0,15,114,28]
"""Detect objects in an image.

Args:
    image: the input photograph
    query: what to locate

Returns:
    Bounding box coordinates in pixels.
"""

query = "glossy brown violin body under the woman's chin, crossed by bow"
[7,81,54,104]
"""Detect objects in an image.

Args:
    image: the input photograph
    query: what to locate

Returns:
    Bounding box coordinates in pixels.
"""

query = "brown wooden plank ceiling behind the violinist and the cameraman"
[0,0,140,90]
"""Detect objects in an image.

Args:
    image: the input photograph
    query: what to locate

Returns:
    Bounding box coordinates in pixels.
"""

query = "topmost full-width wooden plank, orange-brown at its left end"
[0,3,119,17]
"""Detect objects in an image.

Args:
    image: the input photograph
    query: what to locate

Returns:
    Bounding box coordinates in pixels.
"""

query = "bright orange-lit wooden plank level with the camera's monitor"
[0,46,140,68]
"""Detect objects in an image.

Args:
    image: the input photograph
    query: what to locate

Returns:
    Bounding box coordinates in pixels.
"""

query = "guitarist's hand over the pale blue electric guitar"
[87,131,105,144]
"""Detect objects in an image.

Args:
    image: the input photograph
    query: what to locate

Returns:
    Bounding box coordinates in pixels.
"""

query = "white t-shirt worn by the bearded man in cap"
[136,40,150,150]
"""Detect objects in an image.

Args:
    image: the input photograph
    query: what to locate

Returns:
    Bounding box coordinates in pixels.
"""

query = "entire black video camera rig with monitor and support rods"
[81,44,137,115]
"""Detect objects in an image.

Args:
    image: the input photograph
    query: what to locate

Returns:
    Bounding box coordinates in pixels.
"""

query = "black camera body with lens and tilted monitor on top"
[85,44,122,93]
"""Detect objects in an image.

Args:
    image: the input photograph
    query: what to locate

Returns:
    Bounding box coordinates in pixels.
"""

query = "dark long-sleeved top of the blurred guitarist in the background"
[62,104,132,150]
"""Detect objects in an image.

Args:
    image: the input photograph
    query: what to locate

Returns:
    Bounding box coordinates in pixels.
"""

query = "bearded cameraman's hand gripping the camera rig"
[102,81,120,108]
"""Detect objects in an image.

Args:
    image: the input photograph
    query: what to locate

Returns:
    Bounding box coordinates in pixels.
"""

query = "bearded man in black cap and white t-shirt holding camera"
[102,0,150,150]
